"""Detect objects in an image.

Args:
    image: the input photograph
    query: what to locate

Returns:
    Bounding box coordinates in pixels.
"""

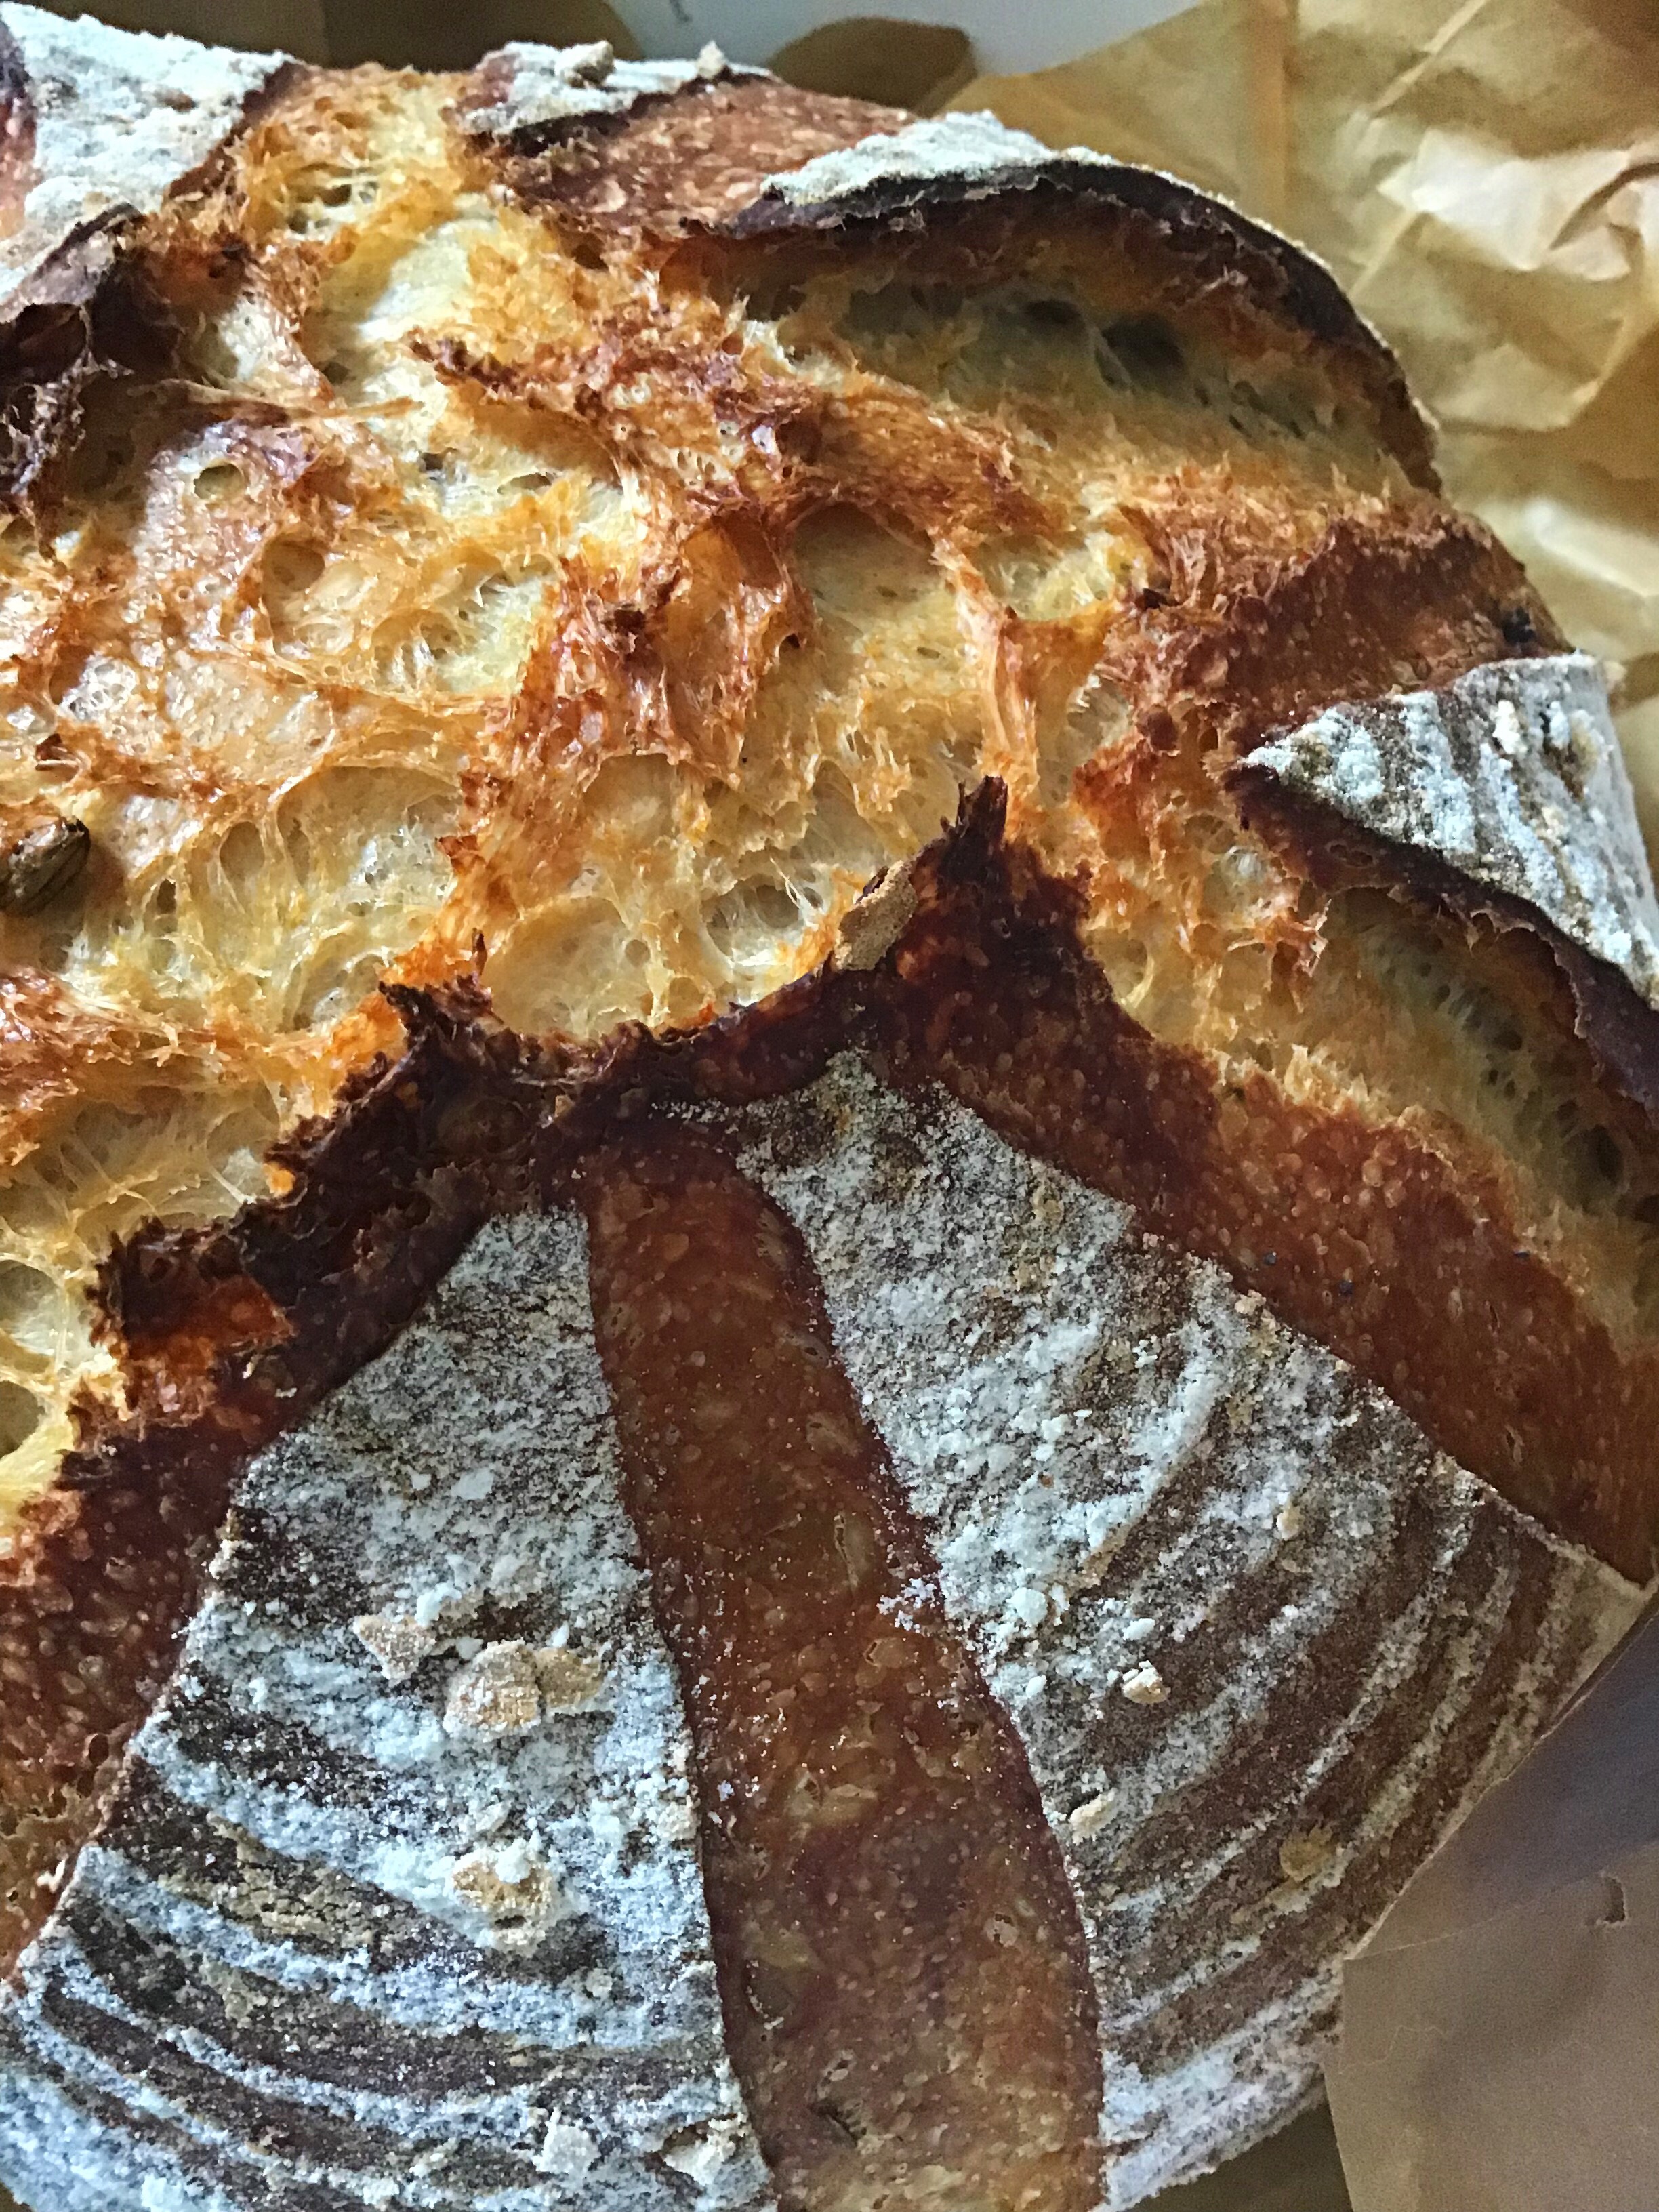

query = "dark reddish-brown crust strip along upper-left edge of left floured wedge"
[0,998,558,1955]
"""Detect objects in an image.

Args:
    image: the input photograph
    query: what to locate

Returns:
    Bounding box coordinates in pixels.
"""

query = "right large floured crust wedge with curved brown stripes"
[741,1059,1637,2205]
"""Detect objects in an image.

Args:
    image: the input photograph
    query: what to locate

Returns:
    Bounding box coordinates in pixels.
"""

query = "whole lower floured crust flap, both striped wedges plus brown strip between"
[0,1057,1639,2212]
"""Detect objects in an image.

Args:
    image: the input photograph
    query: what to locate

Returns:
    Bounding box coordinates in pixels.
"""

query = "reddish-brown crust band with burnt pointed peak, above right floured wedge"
[880,790,1659,1582]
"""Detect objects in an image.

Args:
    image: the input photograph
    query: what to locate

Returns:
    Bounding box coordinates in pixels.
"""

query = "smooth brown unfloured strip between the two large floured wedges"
[581,1124,1119,2212]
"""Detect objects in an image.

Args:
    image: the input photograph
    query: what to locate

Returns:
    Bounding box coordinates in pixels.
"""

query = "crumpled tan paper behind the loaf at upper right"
[949,0,1659,853]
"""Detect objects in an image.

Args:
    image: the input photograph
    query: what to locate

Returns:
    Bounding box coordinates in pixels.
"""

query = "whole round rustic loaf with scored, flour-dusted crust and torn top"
[0,7,1659,2212]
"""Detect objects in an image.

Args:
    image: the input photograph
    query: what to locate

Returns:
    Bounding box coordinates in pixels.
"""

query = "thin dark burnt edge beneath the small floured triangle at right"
[1228,759,1659,1126]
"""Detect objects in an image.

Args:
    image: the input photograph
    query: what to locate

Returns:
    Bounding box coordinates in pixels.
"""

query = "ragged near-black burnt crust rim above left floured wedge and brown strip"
[102,969,852,1380]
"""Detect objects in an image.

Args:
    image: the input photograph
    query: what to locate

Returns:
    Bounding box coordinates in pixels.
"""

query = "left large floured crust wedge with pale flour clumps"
[0,1216,770,2212]
